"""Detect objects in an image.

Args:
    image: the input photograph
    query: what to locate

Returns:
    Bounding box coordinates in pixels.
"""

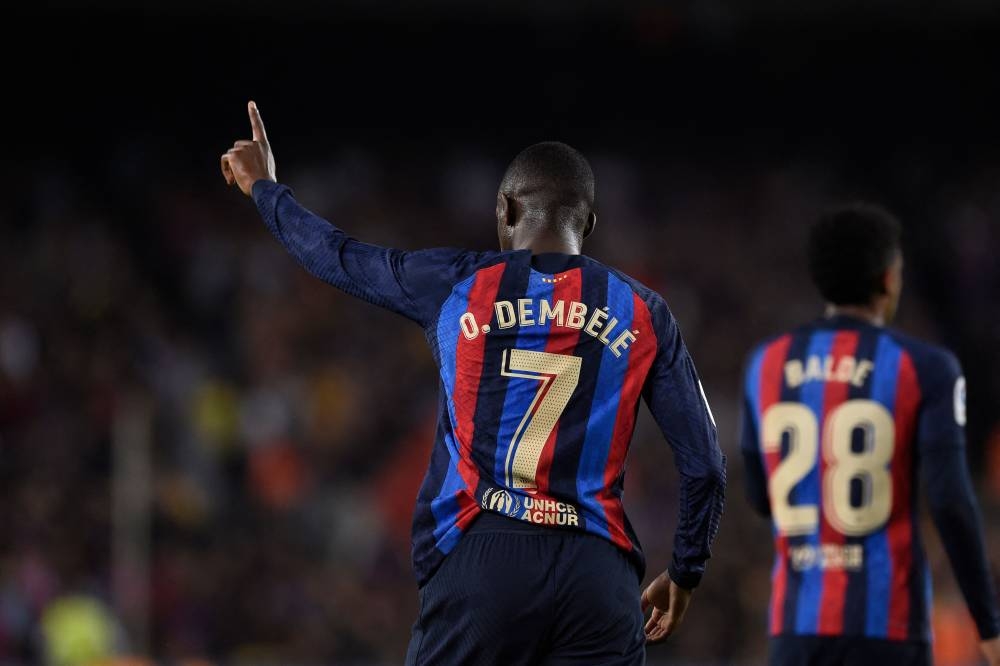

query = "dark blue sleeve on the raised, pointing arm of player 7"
[253,180,482,324]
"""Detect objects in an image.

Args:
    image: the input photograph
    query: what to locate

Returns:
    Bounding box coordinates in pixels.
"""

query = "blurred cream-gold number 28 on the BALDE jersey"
[761,400,896,536]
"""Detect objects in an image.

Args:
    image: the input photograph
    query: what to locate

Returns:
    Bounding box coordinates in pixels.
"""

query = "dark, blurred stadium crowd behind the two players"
[0,0,1000,665]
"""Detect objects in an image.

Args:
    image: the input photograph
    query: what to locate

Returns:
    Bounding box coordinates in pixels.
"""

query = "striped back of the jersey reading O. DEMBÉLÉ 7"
[414,251,714,588]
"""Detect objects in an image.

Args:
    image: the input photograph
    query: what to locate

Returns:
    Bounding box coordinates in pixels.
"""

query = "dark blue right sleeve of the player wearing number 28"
[918,355,1000,640]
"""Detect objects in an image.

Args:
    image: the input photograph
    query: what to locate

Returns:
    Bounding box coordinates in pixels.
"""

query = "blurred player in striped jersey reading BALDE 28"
[741,205,1000,666]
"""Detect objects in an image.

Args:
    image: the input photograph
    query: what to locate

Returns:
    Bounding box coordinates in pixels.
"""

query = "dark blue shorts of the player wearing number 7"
[406,513,646,666]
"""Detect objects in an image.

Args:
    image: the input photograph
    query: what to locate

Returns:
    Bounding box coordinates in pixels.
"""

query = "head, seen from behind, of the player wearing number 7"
[497,141,597,250]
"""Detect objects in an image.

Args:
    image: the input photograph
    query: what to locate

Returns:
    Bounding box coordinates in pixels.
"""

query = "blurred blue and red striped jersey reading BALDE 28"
[741,317,995,641]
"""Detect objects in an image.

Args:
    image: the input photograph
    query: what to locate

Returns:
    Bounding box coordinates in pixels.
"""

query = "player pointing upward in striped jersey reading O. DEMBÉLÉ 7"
[222,102,725,666]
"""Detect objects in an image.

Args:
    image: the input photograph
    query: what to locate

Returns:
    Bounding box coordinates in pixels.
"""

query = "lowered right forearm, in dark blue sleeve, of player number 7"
[667,449,726,590]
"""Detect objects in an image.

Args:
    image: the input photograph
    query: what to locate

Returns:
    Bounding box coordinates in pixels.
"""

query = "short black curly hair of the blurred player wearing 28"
[807,203,902,305]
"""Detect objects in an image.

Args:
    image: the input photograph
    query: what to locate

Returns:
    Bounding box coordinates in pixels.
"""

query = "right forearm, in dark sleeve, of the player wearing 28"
[922,448,1000,639]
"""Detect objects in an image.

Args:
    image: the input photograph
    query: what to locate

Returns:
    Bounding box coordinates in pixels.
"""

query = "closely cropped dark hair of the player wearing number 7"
[500,141,594,206]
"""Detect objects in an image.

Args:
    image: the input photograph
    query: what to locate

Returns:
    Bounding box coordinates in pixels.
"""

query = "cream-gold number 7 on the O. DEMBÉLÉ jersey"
[500,349,582,491]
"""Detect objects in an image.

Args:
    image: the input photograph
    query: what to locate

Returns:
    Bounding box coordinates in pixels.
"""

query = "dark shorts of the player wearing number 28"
[770,636,932,666]
